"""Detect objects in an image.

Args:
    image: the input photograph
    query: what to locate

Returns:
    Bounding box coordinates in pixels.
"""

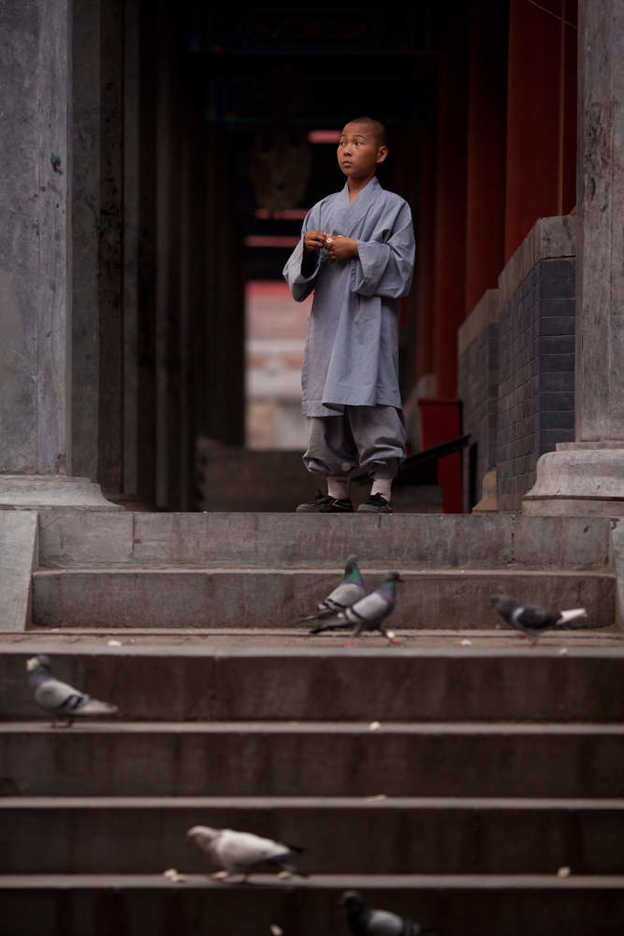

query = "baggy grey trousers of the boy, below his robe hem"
[303,406,405,478]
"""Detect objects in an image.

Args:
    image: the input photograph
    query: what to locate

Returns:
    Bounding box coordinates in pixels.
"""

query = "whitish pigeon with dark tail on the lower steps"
[186,826,305,881]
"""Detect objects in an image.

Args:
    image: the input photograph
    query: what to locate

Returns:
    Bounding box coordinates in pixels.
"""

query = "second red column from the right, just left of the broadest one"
[465,0,508,315]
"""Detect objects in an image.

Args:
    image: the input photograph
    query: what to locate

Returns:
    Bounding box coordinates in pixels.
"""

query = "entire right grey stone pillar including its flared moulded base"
[523,0,624,517]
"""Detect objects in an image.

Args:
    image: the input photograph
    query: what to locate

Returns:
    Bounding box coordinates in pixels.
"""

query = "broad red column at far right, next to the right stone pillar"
[505,0,576,259]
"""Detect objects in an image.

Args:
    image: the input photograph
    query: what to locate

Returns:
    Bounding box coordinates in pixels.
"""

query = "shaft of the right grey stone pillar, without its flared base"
[576,0,624,446]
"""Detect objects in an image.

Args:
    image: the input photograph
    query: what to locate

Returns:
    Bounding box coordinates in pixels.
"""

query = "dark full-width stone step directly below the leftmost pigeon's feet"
[0,722,624,798]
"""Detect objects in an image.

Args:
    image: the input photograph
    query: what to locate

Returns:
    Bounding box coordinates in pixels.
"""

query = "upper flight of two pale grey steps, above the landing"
[32,510,615,630]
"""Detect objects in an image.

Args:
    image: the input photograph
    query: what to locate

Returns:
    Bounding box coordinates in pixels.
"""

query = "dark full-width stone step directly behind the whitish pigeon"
[0,797,624,875]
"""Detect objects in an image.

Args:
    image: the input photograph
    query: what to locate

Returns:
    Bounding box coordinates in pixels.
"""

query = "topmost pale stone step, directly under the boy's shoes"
[39,509,611,570]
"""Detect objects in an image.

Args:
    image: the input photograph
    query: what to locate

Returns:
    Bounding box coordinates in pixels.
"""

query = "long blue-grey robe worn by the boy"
[283,178,414,416]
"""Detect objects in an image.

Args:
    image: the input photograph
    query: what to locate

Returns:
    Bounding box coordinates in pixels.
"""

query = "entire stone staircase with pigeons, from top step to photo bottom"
[0,511,624,936]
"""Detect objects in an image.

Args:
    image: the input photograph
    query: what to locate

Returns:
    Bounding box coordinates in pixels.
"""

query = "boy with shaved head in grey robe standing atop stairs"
[283,117,414,513]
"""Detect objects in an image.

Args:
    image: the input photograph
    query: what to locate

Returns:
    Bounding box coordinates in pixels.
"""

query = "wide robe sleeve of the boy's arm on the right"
[352,202,415,299]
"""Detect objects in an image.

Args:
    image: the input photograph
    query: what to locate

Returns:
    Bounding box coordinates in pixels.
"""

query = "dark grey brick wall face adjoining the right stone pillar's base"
[496,257,576,510]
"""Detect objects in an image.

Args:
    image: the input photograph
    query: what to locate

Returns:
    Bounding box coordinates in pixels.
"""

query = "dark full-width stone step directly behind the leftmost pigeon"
[0,644,624,723]
